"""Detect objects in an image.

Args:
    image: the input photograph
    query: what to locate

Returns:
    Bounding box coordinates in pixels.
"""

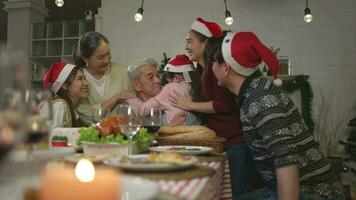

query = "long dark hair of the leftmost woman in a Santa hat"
[56,66,83,127]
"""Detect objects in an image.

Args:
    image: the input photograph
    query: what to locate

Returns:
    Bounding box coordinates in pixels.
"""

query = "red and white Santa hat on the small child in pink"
[163,54,194,82]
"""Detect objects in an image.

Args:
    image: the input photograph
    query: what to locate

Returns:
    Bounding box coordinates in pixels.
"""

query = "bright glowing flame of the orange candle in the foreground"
[75,159,95,183]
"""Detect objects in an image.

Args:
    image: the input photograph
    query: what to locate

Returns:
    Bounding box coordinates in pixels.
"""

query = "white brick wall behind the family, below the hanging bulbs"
[101,0,356,130]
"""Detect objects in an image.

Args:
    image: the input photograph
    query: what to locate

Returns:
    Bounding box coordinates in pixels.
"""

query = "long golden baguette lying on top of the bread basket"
[158,126,214,136]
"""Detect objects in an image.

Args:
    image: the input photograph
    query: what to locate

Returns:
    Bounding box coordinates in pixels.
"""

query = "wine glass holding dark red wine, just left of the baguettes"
[141,108,162,133]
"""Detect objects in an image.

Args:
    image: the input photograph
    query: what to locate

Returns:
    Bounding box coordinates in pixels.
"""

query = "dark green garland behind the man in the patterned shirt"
[283,75,315,133]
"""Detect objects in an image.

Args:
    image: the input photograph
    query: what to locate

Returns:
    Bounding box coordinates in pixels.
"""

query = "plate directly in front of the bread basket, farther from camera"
[149,145,213,155]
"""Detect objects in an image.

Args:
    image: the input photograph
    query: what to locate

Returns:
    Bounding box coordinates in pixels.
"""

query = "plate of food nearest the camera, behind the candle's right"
[103,152,198,171]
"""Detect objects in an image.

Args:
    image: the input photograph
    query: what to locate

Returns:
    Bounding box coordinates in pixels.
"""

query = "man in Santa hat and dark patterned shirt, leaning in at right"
[206,32,343,200]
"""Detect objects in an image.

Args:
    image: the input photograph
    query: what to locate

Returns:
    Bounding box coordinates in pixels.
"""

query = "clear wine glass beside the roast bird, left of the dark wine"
[117,104,141,140]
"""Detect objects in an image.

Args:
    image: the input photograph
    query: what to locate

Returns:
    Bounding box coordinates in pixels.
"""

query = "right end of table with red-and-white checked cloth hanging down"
[124,155,232,200]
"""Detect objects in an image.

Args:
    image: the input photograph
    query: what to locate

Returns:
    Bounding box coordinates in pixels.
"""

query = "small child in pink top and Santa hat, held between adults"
[122,55,200,126]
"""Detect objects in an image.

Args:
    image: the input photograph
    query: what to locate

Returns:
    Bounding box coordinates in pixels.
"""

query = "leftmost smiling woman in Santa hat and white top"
[42,62,88,127]
